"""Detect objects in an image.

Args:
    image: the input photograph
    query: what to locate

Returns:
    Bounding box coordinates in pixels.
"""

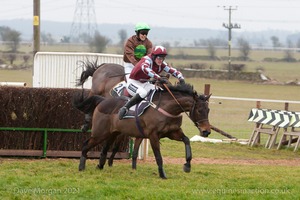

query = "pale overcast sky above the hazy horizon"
[0,0,300,32]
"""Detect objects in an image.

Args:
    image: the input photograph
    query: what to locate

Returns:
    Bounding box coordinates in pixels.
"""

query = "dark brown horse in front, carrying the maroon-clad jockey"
[74,84,210,179]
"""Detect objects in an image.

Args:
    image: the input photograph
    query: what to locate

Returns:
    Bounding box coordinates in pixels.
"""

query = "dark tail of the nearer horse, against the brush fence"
[72,91,104,114]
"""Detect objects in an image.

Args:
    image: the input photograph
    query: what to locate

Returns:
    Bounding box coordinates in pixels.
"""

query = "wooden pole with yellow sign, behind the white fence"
[33,0,40,57]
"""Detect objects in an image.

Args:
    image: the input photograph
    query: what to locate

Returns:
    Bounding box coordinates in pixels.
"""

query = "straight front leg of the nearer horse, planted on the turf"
[149,135,167,179]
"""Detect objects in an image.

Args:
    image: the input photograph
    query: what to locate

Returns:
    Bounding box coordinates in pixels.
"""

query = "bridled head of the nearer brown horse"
[190,94,211,137]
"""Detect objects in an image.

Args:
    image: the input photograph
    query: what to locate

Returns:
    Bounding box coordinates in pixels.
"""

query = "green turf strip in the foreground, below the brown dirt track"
[0,159,300,199]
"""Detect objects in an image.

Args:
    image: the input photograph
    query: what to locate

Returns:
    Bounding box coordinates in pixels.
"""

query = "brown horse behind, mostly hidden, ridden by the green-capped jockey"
[77,60,143,169]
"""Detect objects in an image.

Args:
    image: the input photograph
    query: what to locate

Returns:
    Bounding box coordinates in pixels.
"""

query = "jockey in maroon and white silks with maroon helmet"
[119,46,185,120]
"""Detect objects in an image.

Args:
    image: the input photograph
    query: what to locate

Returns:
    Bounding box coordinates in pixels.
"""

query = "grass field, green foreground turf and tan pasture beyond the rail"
[0,46,300,199]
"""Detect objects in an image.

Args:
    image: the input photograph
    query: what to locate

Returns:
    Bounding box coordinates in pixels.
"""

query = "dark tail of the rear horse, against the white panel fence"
[76,59,104,86]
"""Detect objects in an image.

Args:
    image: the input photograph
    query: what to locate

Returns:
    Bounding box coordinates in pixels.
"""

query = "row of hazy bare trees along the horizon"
[0,26,300,64]
